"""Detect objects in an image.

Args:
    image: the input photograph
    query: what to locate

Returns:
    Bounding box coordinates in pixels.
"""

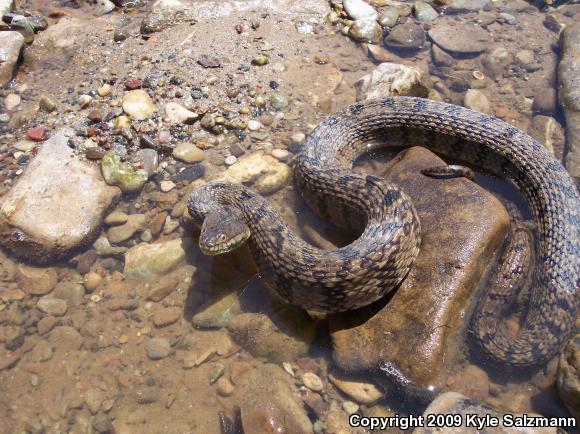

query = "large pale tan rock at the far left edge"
[0,132,120,262]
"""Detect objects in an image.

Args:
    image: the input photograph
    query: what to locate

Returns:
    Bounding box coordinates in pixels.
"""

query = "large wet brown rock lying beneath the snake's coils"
[330,147,509,391]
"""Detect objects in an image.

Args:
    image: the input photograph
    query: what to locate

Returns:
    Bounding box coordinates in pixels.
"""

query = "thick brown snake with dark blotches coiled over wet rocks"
[188,96,580,367]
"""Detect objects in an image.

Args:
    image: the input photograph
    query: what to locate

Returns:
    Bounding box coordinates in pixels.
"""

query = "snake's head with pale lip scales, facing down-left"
[199,206,250,256]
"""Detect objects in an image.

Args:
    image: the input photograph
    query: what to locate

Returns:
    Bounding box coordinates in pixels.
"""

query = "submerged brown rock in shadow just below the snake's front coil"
[228,313,315,363]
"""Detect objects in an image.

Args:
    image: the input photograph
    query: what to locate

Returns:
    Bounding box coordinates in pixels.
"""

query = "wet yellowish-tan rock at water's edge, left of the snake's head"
[123,239,186,279]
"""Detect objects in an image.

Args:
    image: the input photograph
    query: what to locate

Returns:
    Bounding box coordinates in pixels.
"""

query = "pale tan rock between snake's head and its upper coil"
[220,153,291,194]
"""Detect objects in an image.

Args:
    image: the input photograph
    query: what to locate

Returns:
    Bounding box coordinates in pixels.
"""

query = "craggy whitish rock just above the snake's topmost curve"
[354,63,429,101]
